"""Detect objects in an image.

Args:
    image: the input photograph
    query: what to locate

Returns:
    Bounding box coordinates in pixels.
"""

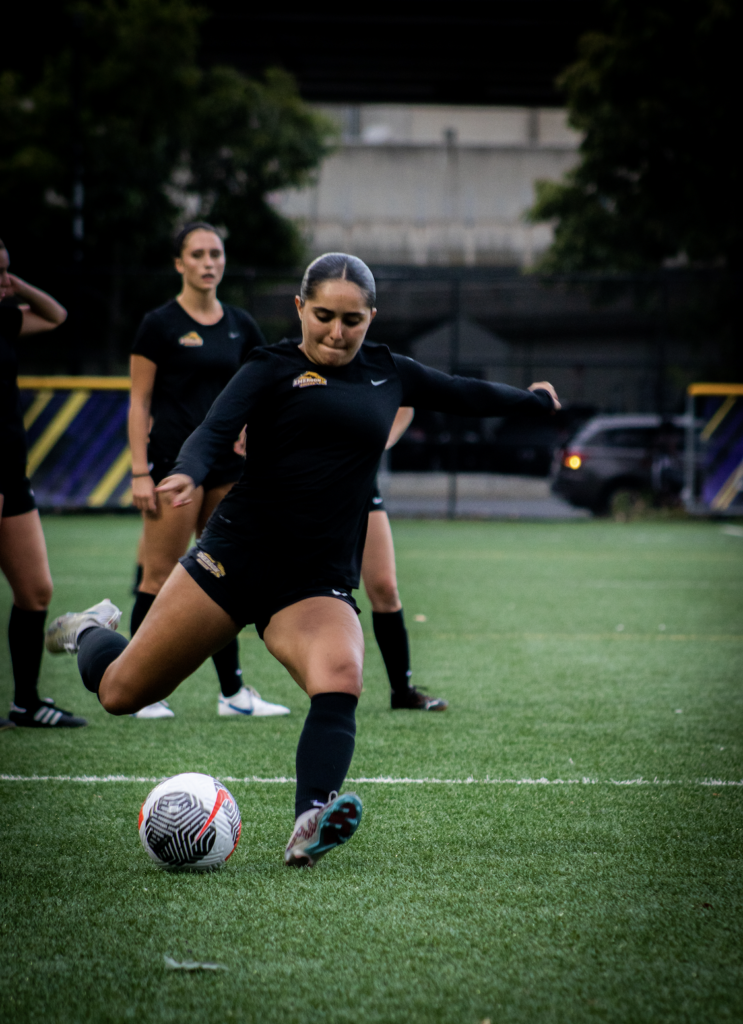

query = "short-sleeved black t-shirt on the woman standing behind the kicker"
[132,299,265,462]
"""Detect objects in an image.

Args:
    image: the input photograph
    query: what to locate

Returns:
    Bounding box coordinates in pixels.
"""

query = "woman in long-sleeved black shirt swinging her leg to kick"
[47,253,558,865]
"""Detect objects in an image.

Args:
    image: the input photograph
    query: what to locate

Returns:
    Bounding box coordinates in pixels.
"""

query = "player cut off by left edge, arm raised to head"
[0,234,87,729]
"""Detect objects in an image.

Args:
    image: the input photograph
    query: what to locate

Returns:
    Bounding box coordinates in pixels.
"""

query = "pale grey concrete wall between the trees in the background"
[273,104,579,266]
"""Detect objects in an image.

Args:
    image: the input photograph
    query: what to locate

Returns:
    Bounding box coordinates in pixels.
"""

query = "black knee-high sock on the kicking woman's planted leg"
[295,693,358,817]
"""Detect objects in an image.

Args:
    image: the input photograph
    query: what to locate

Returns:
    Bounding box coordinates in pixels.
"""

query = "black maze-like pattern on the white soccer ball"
[144,793,217,867]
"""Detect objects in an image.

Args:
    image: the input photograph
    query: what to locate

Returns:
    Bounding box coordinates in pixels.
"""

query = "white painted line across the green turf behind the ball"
[0,774,743,786]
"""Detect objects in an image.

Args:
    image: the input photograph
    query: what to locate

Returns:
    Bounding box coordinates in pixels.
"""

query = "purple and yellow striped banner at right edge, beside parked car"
[683,384,743,515]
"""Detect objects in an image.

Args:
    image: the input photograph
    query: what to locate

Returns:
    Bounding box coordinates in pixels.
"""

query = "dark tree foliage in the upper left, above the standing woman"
[0,0,332,266]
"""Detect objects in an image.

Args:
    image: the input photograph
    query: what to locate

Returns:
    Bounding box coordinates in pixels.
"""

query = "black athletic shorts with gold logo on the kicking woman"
[180,532,360,640]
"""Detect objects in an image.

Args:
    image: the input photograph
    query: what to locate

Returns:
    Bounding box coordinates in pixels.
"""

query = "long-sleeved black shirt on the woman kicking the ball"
[174,341,553,591]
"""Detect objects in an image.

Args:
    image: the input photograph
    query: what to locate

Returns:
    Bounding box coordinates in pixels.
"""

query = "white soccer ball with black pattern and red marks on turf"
[139,771,242,871]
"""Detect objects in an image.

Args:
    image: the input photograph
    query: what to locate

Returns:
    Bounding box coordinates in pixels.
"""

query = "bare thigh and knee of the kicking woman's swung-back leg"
[98,565,239,715]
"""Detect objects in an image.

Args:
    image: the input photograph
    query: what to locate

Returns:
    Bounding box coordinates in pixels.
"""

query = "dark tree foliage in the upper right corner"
[530,0,743,271]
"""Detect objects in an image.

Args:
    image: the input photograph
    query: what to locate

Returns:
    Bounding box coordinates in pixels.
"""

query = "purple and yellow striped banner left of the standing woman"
[18,377,132,510]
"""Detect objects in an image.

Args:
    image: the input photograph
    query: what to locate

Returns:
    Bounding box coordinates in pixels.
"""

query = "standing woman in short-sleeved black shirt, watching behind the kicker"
[129,221,289,718]
